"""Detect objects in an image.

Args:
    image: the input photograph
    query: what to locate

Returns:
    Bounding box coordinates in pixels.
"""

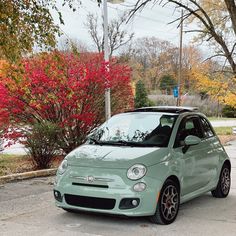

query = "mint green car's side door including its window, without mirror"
[174,115,210,196]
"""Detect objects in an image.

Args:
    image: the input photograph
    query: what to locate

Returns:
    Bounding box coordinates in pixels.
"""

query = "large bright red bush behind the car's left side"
[0,51,133,153]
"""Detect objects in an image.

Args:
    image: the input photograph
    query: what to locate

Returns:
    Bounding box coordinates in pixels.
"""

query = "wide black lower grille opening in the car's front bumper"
[65,194,116,210]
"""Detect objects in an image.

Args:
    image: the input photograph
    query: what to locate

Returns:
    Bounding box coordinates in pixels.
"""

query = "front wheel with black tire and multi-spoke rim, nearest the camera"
[150,179,180,225]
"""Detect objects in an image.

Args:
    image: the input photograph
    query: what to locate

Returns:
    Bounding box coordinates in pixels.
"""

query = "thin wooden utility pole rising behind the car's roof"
[177,10,183,106]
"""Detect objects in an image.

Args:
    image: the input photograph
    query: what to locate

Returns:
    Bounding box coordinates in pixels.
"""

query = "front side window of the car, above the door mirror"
[174,116,203,148]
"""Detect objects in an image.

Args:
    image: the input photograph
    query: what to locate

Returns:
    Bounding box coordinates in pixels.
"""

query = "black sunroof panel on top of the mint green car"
[128,106,199,114]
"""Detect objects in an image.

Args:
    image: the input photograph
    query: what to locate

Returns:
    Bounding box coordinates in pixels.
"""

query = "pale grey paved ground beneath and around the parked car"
[0,142,236,236]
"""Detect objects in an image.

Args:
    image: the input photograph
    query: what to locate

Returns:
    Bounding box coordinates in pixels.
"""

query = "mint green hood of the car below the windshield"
[66,144,169,169]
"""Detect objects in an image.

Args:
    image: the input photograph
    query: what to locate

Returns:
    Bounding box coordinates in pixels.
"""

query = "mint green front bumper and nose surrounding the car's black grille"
[54,167,161,216]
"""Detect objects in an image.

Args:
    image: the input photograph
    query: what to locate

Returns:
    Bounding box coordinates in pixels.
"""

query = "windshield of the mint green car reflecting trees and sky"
[88,112,178,147]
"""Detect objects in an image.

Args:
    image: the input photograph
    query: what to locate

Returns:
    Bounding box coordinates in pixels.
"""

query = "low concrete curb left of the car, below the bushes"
[0,168,57,184]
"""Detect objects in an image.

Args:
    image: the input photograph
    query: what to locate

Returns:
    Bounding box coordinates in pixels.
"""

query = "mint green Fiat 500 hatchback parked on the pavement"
[54,107,231,224]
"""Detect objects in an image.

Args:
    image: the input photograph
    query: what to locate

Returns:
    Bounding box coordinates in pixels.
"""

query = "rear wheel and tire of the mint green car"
[211,164,231,198]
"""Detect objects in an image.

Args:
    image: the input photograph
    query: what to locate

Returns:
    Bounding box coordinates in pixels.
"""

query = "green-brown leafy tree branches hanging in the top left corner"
[0,0,80,62]
